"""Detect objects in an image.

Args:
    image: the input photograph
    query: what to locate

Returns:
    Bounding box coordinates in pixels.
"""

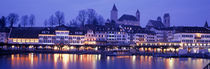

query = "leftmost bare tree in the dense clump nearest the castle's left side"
[76,10,87,27]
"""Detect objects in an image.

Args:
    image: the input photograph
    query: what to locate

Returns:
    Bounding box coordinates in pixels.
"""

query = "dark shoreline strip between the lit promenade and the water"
[0,50,210,59]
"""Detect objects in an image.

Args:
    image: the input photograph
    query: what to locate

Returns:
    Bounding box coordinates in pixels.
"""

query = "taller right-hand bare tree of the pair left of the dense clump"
[55,11,64,26]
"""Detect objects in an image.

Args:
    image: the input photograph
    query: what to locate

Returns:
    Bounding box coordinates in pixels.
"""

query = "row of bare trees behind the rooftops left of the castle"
[0,9,105,27]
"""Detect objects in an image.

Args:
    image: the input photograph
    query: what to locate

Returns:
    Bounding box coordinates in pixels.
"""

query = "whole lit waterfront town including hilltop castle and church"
[0,5,210,52]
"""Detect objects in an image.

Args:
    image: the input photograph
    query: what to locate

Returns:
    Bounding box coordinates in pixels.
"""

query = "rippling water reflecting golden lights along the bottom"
[0,53,210,69]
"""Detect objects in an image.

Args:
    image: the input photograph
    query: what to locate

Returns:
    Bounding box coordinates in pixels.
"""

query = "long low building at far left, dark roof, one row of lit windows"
[8,27,43,44]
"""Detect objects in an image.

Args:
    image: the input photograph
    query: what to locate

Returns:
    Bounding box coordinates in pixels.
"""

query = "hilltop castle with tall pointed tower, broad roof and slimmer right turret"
[110,4,140,26]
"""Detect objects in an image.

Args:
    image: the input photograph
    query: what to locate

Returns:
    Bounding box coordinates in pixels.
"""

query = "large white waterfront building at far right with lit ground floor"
[172,27,210,53]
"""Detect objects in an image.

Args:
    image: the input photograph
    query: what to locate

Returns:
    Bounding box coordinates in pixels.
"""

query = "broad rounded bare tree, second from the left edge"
[7,13,19,27]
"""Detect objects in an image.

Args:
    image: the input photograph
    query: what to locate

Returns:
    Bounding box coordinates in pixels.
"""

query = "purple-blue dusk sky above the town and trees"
[0,0,210,27]
